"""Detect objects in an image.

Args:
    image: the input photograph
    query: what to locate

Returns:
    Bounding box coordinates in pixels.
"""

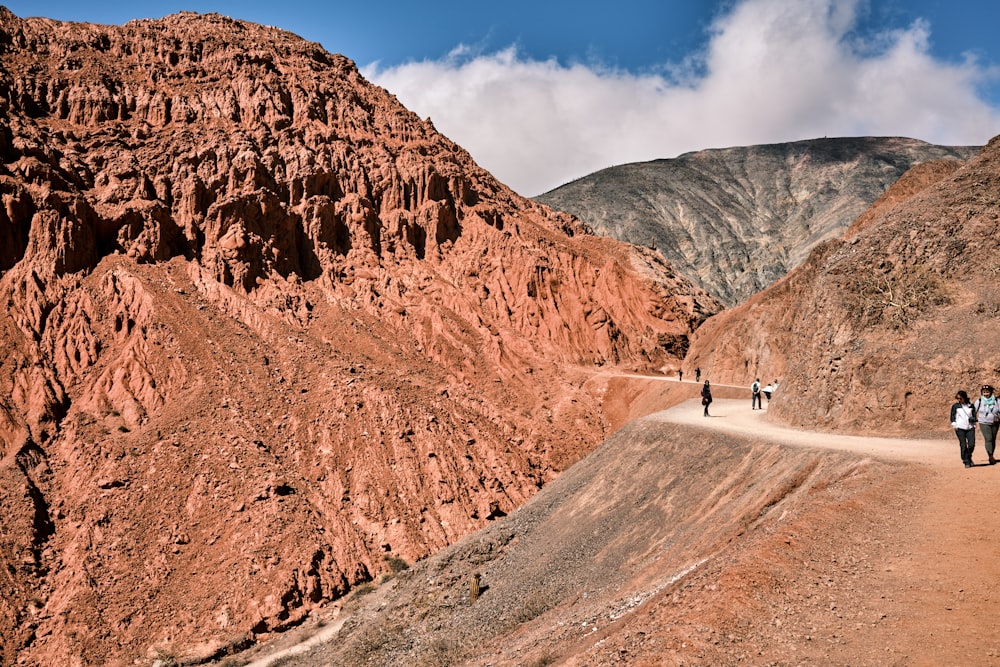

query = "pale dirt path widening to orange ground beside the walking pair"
[648,399,1000,666]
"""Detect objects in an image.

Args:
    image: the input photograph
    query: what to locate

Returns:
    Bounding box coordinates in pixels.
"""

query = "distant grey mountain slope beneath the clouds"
[535,137,980,306]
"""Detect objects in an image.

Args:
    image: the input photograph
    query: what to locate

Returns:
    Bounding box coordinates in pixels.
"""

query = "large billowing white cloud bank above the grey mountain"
[365,0,1000,196]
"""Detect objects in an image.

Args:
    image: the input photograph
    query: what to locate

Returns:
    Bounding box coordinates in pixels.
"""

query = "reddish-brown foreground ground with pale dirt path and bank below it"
[228,382,1000,667]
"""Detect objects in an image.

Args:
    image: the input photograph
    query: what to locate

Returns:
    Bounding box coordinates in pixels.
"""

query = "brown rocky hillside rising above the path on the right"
[687,138,1000,436]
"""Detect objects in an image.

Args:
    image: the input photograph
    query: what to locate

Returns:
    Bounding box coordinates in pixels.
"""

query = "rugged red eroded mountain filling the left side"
[0,8,719,665]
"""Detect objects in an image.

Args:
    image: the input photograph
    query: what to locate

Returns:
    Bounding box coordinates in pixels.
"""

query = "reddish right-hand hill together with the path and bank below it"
[276,137,1000,667]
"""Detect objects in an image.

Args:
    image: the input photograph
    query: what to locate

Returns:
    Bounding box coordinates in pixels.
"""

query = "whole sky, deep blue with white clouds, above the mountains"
[7,0,1000,196]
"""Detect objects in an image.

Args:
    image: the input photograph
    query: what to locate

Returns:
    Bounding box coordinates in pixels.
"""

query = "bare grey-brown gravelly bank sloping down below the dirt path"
[300,420,919,667]
